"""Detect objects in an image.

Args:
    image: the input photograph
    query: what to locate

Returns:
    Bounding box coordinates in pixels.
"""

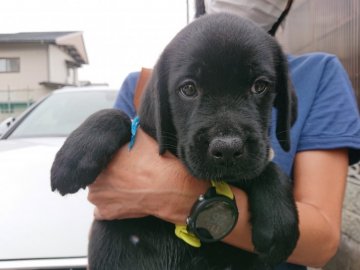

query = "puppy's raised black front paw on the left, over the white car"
[51,109,131,195]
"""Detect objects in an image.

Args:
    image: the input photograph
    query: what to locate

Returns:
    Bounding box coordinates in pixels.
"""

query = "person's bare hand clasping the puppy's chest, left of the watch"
[88,129,209,224]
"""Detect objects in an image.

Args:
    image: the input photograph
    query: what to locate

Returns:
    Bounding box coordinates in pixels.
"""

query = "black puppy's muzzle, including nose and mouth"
[179,136,268,184]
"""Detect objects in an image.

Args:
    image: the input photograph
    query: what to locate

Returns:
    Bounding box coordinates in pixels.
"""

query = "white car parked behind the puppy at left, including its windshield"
[0,87,117,270]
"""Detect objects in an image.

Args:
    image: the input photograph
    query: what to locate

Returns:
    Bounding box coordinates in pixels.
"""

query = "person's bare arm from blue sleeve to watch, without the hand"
[225,149,348,267]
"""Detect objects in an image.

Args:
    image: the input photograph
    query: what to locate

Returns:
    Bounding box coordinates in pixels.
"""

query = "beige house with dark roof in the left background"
[0,31,88,120]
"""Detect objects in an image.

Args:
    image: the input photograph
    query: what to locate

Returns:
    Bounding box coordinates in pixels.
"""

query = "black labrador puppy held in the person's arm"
[51,14,299,270]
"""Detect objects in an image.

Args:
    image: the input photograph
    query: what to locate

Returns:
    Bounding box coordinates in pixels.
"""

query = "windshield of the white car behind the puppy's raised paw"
[8,91,116,138]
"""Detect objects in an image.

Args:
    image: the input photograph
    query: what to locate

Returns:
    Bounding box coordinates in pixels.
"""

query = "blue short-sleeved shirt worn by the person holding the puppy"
[115,53,360,270]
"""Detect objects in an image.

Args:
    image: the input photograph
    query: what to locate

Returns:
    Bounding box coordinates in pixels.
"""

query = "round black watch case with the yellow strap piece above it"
[186,181,239,243]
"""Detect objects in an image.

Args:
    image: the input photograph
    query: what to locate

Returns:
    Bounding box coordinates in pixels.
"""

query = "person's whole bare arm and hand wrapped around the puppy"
[88,130,348,267]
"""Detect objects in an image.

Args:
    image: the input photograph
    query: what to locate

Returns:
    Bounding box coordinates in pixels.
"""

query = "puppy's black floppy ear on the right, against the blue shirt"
[274,51,297,151]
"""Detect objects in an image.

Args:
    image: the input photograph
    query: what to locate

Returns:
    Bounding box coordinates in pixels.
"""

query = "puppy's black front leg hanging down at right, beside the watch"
[249,164,299,266]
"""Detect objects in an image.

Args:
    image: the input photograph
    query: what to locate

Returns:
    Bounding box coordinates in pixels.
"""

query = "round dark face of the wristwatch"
[194,199,237,242]
